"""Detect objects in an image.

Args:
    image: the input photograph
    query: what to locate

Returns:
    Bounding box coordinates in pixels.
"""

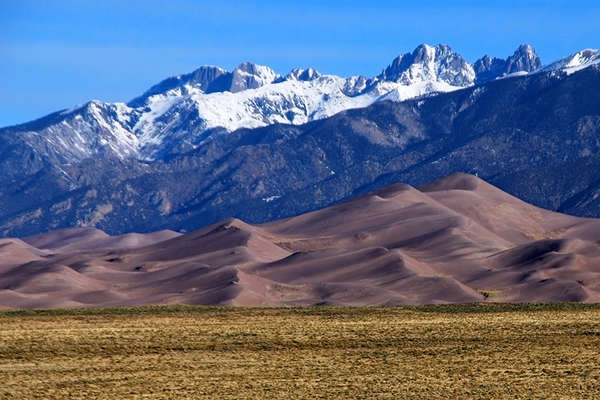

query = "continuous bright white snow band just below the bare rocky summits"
[133,70,468,159]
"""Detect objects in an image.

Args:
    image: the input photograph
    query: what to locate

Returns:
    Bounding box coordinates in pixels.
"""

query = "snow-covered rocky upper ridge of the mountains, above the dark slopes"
[0,44,599,164]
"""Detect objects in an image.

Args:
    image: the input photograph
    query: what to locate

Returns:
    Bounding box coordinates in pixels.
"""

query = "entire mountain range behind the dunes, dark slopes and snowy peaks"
[0,45,600,236]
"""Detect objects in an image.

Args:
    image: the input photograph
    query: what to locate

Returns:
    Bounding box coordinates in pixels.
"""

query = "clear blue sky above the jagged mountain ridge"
[0,0,600,126]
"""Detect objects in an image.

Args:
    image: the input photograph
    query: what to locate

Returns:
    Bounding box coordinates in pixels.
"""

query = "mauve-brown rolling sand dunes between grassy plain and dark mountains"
[0,174,600,308]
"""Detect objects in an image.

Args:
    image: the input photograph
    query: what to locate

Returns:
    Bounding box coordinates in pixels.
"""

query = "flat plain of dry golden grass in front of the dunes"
[0,305,600,400]
